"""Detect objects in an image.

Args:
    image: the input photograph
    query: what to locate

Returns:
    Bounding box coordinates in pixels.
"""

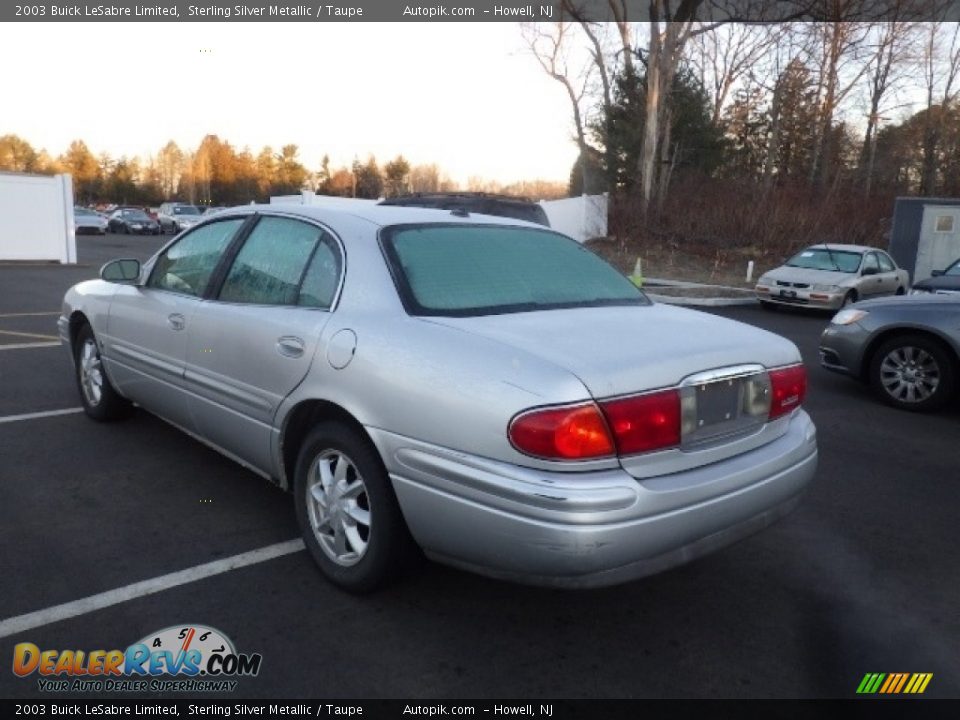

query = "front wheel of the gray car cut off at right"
[869,334,957,412]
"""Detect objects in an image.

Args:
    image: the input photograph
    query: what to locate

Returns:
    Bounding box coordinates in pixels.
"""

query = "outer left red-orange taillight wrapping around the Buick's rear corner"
[509,403,614,460]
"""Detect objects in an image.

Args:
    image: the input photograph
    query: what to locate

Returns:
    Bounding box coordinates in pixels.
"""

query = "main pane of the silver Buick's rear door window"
[219,217,323,305]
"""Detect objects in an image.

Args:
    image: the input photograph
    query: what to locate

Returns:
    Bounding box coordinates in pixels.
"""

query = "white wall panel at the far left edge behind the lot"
[0,173,77,263]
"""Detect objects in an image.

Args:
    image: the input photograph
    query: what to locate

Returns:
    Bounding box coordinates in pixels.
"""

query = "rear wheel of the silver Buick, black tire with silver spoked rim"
[294,422,416,594]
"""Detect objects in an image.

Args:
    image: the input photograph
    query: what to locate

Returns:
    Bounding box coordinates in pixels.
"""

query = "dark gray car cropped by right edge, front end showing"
[820,295,960,410]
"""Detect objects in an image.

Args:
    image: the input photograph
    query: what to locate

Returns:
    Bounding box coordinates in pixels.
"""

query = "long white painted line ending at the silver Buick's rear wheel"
[0,539,306,638]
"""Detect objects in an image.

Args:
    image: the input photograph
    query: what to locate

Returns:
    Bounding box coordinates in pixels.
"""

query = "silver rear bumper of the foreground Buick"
[371,410,817,587]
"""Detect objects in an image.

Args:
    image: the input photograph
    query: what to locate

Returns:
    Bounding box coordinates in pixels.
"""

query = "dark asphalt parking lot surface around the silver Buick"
[0,235,960,699]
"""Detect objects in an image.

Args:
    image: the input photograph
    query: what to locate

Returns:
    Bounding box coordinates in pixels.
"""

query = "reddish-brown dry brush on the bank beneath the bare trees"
[589,176,893,287]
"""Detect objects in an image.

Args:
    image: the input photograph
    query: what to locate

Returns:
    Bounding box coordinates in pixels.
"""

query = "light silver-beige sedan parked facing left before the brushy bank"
[756,244,910,310]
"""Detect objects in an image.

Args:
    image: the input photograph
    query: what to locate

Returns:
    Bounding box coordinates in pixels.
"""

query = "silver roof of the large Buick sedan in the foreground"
[217,203,549,230]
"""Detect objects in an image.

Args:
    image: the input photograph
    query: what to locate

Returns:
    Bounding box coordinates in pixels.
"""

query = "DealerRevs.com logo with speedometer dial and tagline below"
[13,624,263,692]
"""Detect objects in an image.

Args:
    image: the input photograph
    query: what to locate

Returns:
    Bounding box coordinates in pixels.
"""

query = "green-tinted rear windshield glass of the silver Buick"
[383,225,648,316]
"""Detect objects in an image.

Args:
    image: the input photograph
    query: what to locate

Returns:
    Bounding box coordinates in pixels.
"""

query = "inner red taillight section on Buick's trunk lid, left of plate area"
[600,390,680,455]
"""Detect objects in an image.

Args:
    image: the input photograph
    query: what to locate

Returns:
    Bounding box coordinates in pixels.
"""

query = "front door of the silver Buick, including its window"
[103,218,244,427]
